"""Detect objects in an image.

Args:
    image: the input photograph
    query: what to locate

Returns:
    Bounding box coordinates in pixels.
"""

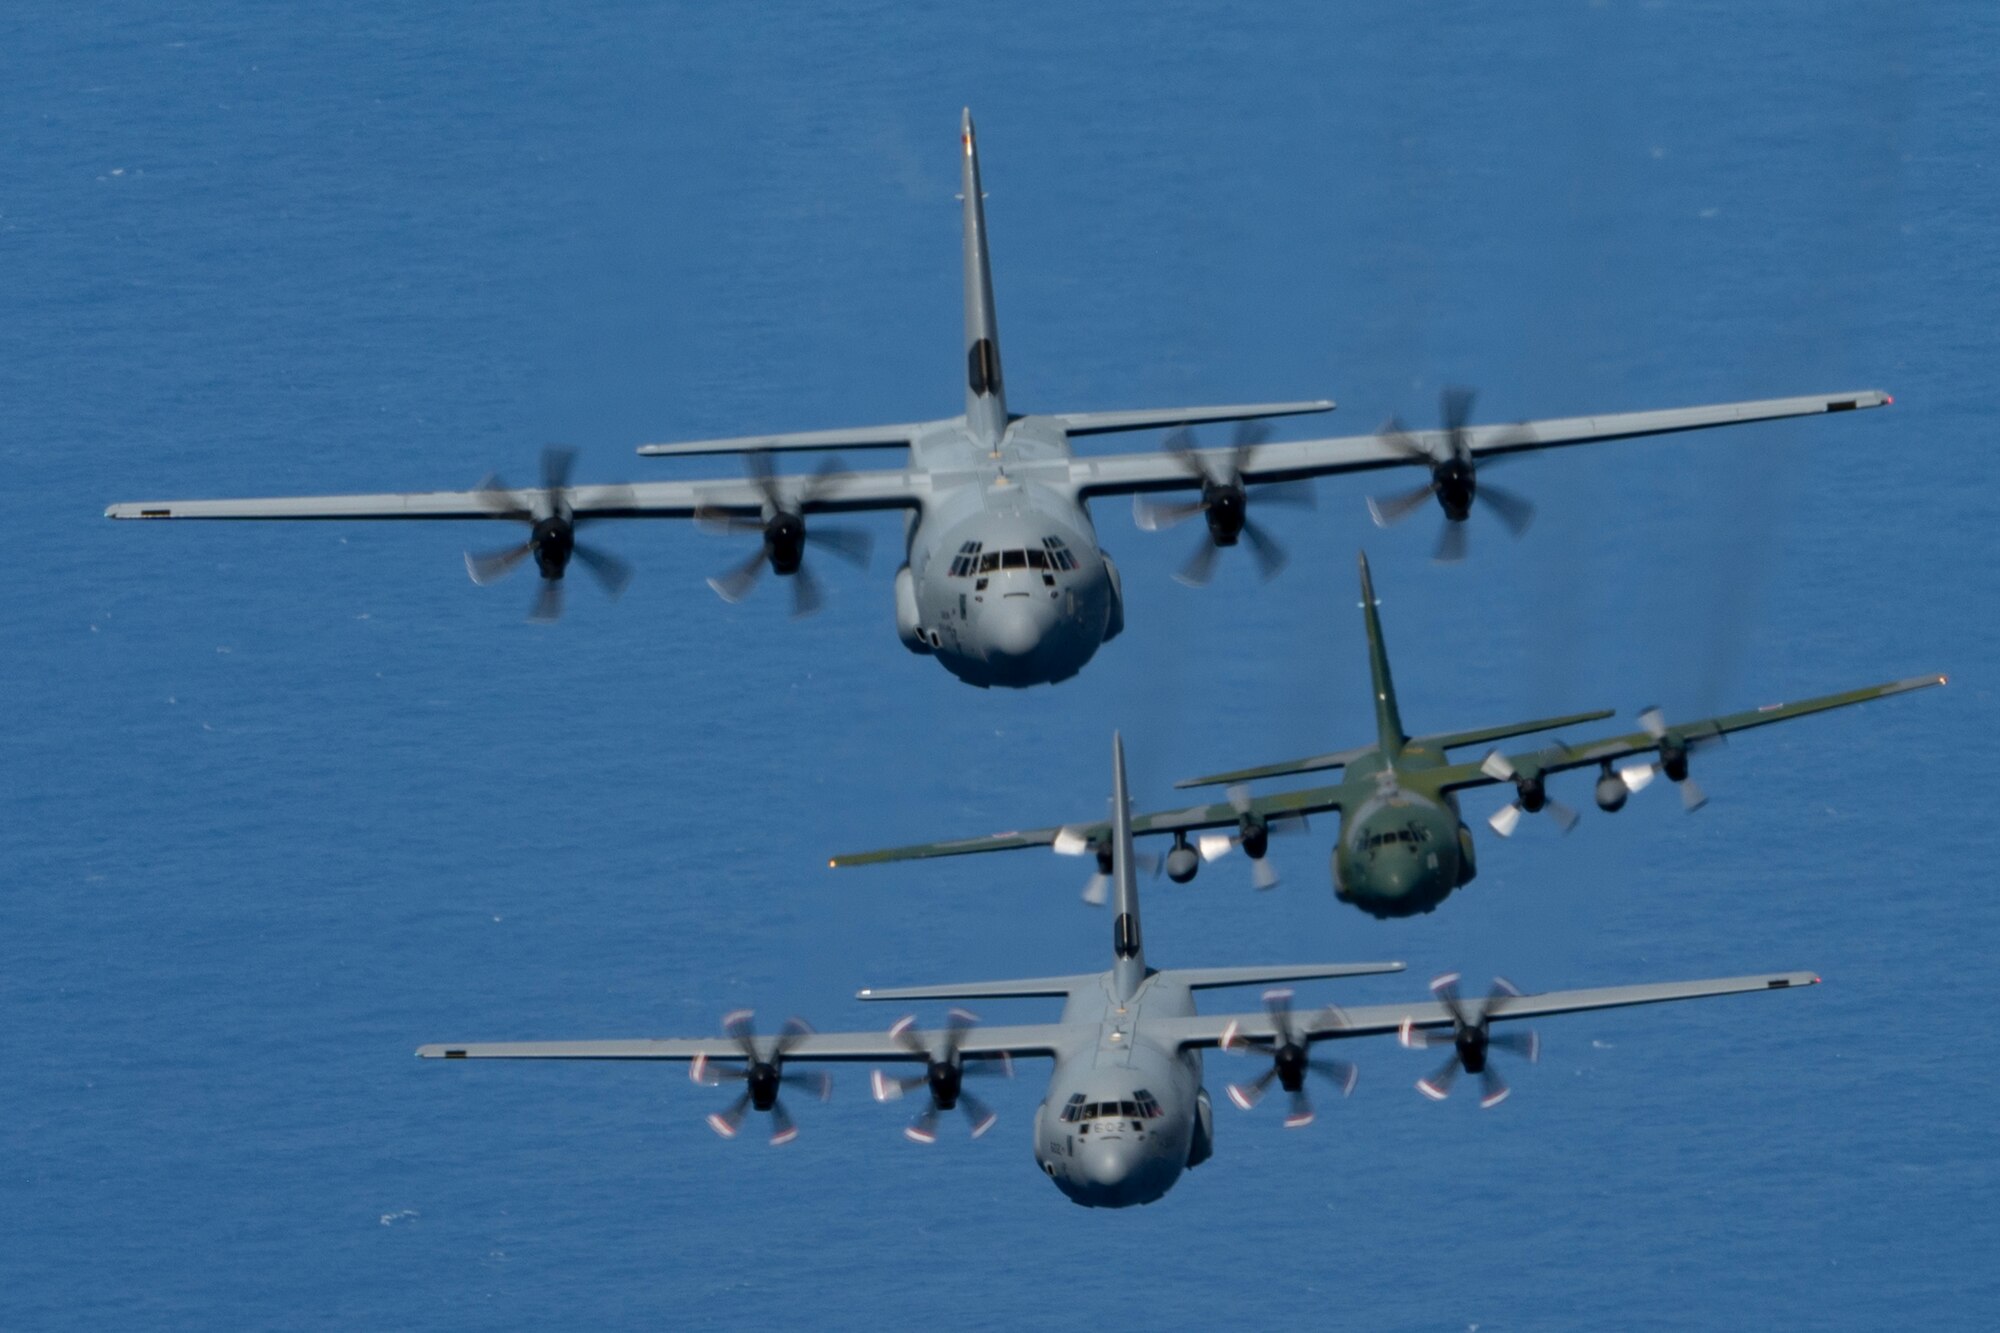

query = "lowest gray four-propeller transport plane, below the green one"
[418,737,1820,1209]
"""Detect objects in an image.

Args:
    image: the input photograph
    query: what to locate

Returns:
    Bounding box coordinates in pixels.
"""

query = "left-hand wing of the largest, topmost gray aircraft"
[104,468,930,518]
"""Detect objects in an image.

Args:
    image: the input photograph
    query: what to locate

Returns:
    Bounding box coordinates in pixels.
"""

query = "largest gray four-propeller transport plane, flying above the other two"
[117,110,1890,689]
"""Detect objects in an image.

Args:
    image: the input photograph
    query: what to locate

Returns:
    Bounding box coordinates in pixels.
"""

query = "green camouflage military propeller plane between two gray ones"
[830,554,1944,917]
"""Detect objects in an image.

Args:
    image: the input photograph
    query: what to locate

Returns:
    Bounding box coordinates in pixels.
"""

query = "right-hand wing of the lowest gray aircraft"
[1146,973,1820,1049]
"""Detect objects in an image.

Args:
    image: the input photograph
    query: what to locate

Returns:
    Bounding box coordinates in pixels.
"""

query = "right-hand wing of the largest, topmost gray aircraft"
[1070,388,1892,496]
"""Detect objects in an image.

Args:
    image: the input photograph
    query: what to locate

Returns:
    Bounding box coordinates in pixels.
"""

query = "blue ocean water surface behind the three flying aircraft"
[0,0,2000,1329]
